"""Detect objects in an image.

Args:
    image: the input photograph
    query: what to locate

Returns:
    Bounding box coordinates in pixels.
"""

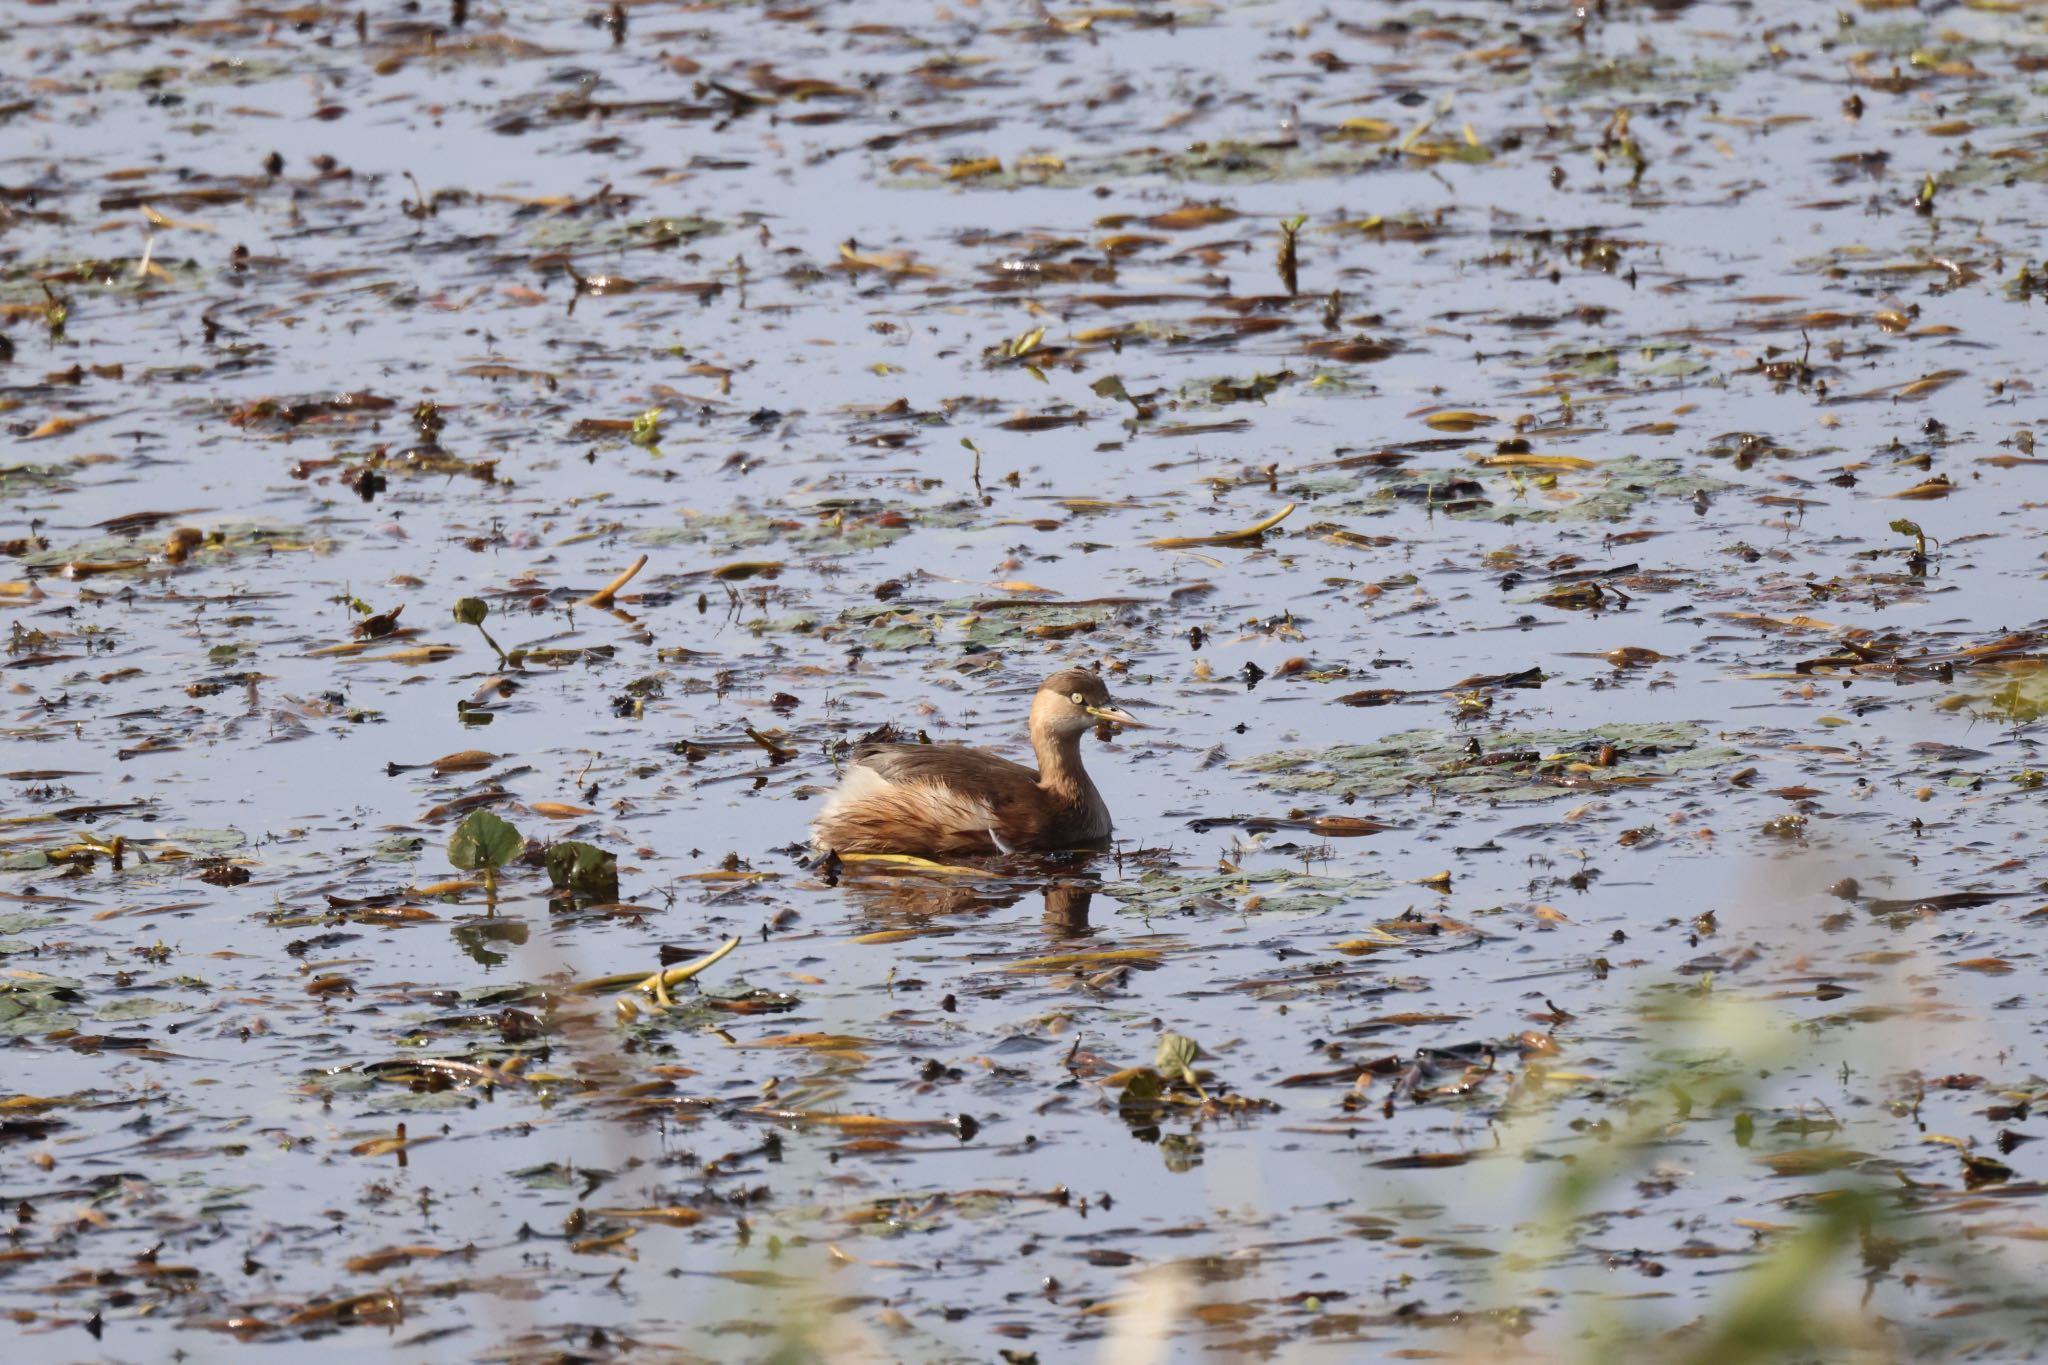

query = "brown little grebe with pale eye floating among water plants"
[811,669,1145,855]
